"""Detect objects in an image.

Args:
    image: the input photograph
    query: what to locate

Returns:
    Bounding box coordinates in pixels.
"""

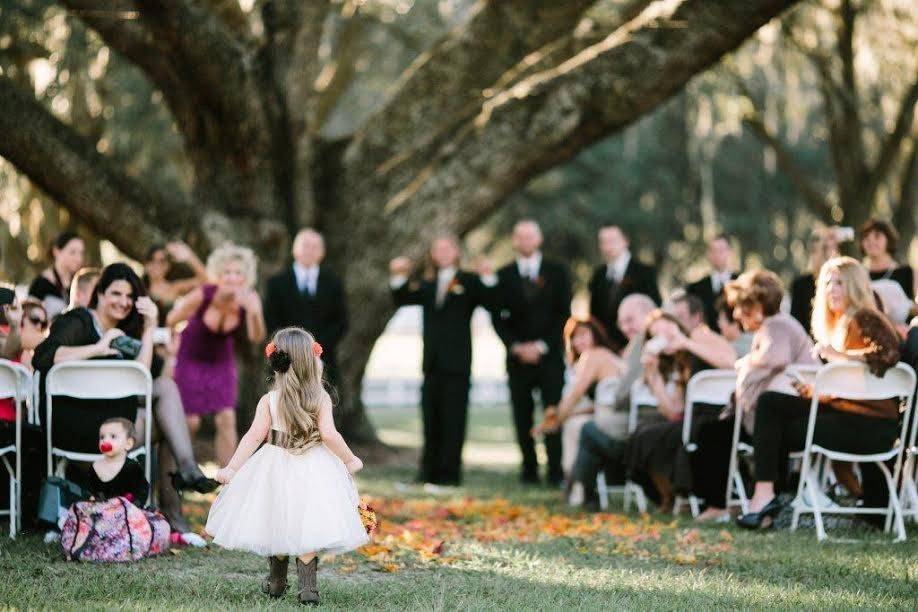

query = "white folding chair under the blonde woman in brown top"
[791,361,915,542]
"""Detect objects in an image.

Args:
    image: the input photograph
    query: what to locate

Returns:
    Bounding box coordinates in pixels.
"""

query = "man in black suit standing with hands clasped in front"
[492,220,571,485]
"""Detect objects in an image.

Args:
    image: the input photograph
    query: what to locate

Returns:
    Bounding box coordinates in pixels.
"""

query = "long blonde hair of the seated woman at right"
[811,257,877,348]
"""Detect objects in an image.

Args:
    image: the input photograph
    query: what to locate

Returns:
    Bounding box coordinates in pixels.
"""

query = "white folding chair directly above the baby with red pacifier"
[45,359,153,500]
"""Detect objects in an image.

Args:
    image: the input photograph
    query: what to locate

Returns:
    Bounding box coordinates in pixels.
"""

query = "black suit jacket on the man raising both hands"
[392,270,497,376]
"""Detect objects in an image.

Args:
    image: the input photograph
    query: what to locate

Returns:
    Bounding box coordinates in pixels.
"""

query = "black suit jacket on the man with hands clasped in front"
[492,258,571,365]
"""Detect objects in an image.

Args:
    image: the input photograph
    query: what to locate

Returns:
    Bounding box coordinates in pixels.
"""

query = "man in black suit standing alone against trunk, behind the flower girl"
[265,228,347,386]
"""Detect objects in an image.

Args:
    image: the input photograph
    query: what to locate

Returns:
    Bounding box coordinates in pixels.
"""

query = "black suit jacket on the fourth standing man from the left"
[589,257,660,348]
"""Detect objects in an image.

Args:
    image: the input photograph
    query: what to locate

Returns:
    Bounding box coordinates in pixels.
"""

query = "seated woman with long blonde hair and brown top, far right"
[737,257,899,529]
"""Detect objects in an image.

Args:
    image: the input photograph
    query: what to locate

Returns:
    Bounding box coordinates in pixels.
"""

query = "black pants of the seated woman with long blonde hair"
[753,391,898,506]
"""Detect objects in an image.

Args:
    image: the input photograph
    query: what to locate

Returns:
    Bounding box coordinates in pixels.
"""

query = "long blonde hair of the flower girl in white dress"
[269,327,330,453]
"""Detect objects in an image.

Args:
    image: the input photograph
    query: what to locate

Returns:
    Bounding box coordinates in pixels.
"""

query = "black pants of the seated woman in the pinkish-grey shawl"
[689,418,749,508]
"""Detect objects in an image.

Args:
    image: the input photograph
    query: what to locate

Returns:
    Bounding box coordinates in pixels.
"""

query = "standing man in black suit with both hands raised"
[389,235,497,486]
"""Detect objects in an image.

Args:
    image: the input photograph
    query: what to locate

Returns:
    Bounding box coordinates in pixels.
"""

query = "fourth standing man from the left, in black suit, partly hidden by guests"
[589,225,660,350]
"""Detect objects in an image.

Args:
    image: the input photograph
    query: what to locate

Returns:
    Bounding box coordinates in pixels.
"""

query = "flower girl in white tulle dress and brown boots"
[206,327,368,604]
